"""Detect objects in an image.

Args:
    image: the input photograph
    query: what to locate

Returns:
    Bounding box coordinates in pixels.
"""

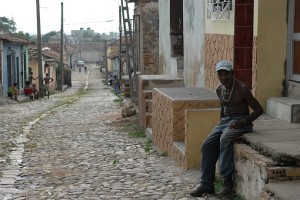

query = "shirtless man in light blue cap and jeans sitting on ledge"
[190,61,263,197]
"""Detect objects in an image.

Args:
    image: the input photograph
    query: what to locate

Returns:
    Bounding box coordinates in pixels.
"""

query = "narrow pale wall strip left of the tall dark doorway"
[159,0,172,75]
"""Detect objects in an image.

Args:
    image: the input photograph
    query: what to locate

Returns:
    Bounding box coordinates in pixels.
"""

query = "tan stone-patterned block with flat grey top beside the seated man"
[152,88,220,155]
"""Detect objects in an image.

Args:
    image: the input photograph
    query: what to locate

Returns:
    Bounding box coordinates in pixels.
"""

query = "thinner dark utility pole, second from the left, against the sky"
[59,2,64,90]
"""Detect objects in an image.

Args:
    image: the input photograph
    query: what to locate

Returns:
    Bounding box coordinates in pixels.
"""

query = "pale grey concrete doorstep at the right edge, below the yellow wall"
[266,97,300,123]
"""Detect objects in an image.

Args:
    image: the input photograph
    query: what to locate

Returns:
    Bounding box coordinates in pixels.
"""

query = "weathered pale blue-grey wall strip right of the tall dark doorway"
[183,0,205,87]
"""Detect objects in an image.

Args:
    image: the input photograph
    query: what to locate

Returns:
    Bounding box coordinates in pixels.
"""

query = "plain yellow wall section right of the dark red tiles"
[254,0,287,108]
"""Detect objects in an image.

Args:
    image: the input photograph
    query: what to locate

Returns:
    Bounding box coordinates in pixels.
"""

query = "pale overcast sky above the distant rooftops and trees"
[0,0,134,34]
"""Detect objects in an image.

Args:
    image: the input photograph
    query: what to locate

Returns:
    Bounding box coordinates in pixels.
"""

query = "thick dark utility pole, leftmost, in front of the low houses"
[36,0,44,97]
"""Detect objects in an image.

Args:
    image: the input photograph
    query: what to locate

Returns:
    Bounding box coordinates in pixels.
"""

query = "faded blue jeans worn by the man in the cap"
[200,116,253,189]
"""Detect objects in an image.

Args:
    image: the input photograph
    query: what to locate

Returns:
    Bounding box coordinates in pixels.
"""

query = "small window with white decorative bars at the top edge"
[207,0,232,20]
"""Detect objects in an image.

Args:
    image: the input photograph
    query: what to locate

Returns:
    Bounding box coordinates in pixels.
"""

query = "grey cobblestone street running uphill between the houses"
[0,66,211,200]
